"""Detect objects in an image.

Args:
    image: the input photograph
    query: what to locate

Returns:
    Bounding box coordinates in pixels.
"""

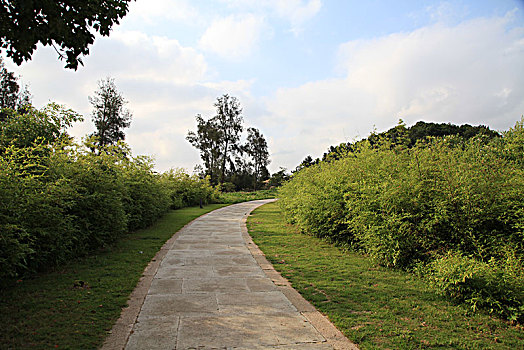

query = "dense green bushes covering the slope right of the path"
[279,118,524,322]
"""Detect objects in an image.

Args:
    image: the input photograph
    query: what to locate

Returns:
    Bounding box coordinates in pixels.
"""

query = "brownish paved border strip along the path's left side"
[100,206,228,350]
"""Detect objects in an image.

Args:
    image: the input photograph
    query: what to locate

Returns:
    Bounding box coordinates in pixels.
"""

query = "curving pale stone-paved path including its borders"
[104,200,356,350]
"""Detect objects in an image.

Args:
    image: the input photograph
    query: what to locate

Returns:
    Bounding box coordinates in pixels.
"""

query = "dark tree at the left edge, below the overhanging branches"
[0,57,31,113]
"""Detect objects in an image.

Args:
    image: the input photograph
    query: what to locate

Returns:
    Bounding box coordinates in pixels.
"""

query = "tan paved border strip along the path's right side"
[241,199,358,350]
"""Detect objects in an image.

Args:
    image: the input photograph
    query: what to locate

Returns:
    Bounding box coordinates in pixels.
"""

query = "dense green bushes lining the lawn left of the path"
[0,105,214,281]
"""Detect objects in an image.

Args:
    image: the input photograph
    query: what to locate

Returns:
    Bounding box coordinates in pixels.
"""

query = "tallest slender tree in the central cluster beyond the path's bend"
[213,94,244,183]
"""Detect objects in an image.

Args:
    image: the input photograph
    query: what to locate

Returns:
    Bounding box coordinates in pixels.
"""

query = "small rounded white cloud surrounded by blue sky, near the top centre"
[200,14,264,60]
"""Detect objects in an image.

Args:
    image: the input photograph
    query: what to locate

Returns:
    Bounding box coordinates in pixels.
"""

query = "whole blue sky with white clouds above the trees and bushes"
[5,0,524,172]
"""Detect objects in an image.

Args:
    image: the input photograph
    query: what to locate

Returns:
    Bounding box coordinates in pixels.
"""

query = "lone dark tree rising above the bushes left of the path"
[89,78,132,148]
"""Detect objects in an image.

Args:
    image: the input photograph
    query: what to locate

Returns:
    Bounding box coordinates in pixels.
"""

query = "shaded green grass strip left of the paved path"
[0,204,224,349]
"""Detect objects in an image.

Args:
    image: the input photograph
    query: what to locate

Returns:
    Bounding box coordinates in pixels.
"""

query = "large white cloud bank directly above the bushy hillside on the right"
[266,18,524,168]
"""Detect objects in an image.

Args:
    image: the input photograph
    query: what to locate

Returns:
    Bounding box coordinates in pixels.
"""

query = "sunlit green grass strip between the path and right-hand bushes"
[248,203,524,349]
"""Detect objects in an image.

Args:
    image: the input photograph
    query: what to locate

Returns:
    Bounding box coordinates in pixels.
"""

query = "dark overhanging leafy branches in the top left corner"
[0,0,135,70]
